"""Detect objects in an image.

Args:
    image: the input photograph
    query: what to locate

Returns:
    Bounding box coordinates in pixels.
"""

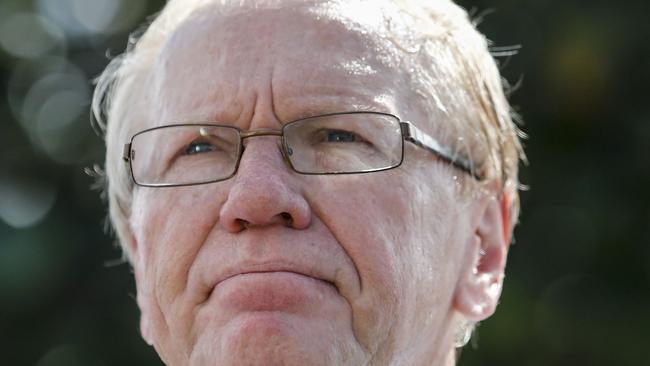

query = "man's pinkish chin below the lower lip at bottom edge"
[189,312,365,366]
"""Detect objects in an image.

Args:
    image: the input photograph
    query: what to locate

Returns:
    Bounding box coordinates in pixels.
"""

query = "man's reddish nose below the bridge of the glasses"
[219,137,311,233]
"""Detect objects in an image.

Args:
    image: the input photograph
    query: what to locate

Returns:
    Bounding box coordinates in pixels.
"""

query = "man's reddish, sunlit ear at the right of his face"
[454,193,510,322]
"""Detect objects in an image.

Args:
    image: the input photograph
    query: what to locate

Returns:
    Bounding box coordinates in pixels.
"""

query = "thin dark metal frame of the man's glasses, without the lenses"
[122,111,483,188]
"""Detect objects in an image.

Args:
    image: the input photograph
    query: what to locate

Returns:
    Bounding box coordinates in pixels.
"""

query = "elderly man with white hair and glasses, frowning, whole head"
[94,0,521,366]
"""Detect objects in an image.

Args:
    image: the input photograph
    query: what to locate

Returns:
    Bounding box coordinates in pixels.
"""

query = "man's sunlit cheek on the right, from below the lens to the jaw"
[312,170,456,344]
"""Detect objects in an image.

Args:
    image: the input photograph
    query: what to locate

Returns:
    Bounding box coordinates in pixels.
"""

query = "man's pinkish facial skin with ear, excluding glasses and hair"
[125,6,507,365]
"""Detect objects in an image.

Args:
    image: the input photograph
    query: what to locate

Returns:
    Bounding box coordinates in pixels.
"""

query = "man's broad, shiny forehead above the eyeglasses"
[149,2,426,125]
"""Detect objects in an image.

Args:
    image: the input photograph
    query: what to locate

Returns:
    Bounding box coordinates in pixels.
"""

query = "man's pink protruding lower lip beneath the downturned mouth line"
[212,271,336,312]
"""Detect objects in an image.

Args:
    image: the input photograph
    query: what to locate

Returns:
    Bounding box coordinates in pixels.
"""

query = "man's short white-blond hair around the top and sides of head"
[92,0,524,259]
